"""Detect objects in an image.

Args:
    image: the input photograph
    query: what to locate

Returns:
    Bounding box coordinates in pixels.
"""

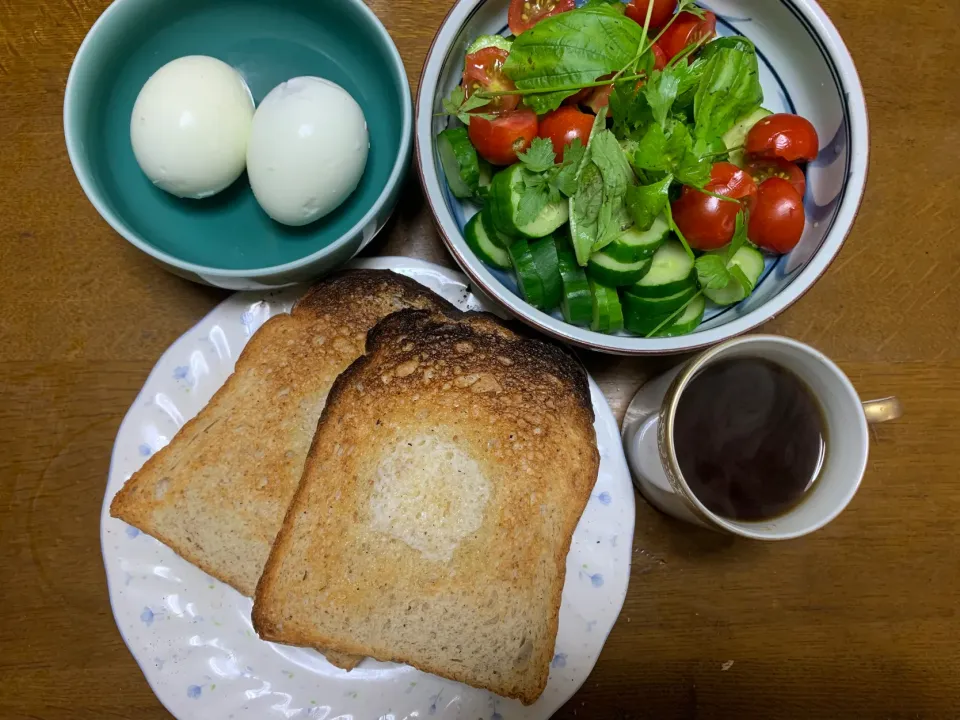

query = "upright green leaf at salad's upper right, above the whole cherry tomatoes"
[693,48,763,140]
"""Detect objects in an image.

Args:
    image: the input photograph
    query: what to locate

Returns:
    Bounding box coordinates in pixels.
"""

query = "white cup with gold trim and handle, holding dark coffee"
[622,335,903,540]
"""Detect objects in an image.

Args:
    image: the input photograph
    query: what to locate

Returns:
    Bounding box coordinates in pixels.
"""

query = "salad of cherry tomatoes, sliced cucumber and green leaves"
[437,0,819,337]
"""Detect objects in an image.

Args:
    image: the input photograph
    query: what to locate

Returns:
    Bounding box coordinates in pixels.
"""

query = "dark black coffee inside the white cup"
[674,359,826,521]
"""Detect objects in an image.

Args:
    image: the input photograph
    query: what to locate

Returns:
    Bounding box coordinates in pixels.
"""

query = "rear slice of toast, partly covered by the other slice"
[110,270,453,669]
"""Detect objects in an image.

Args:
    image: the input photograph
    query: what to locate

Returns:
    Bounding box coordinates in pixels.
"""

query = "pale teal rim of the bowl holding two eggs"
[63,0,413,279]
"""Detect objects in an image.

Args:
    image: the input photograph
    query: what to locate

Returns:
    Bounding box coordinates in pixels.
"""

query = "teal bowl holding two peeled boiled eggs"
[64,0,413,290]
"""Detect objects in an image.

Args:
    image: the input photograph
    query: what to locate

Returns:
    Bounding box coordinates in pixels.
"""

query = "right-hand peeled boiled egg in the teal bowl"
[247,77,370,225]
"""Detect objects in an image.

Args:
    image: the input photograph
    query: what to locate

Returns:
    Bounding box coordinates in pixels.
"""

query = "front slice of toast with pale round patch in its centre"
[253,311,600,704]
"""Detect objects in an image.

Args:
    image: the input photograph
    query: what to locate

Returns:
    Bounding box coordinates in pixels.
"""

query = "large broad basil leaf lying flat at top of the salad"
[503,4,643,115]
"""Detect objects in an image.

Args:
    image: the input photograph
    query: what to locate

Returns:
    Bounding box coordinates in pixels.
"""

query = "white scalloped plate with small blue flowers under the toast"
[100,258,635,720]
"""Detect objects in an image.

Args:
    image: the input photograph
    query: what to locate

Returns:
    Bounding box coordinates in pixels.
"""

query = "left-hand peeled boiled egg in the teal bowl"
[130,55,254,198]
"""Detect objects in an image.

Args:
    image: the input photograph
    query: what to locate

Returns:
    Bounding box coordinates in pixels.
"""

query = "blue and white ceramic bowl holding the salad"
[416,0,869,355]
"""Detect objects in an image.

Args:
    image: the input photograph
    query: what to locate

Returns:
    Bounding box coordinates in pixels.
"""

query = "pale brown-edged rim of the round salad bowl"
[414,0,870,356]
